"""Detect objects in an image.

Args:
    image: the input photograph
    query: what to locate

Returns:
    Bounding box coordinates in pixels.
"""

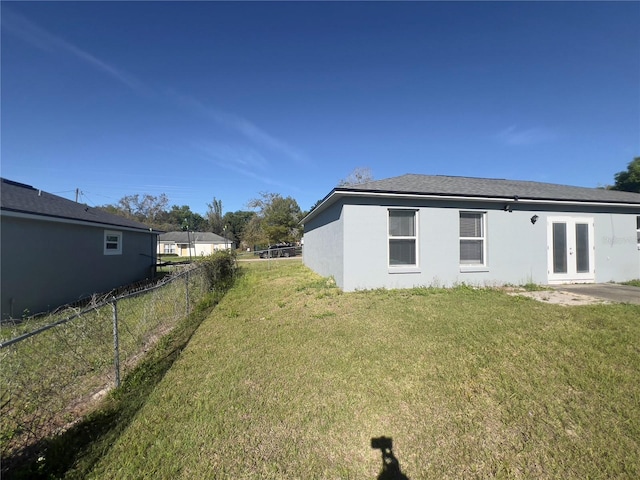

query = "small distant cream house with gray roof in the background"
[158,232,234,257]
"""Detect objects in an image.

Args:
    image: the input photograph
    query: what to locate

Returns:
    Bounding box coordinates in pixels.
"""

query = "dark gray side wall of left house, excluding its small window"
[0,215,156,318]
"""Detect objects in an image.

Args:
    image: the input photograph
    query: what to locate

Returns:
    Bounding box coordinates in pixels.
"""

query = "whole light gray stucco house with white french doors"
[301,175,640,291]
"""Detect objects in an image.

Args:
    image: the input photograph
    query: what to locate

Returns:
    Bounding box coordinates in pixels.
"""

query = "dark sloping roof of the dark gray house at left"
[0,178,155,232]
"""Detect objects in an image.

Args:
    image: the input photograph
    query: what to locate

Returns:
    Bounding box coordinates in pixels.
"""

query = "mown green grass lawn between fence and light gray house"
[86,262,640,480]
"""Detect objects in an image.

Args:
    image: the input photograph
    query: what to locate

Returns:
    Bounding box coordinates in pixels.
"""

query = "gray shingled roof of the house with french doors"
[335,174,640,205]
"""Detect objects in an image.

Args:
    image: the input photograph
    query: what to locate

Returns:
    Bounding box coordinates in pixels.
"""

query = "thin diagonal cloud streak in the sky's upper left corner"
[2,8,142,90]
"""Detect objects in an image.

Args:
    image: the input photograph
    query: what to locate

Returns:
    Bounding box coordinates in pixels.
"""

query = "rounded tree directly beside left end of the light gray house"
[249,192,302,243]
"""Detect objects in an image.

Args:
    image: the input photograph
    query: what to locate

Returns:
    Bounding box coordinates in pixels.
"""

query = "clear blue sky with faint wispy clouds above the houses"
[1,1,640,213]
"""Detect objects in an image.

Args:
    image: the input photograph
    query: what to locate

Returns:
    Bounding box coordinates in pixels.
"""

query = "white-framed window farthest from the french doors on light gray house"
[389,209,418,267]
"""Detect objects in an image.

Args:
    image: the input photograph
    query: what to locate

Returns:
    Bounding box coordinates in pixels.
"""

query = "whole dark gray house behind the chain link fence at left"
[0,179,157,319]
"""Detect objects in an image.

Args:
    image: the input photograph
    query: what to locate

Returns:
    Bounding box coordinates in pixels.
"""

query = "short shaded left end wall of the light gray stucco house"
[303,202,345,288]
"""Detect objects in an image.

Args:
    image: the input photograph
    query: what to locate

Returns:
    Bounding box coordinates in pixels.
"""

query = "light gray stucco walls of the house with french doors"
[304,198,640,291]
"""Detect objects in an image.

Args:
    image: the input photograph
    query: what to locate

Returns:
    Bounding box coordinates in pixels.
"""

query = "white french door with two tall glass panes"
[547,217,595,283]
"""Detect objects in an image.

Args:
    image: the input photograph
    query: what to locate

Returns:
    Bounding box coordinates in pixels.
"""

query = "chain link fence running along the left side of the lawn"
[0,266,208,459]
